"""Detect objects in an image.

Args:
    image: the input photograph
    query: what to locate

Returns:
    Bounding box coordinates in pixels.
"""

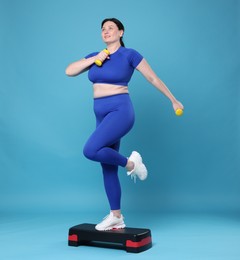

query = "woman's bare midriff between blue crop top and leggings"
[93,83,128,98]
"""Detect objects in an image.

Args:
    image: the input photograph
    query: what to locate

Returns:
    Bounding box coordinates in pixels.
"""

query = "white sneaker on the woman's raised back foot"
[127,151,148,182]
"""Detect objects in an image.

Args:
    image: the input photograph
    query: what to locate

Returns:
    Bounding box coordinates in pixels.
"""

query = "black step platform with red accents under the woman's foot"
[68,223,152,253]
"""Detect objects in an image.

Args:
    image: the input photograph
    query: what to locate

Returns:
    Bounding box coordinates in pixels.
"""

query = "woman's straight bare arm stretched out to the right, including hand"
[136,59,184,111]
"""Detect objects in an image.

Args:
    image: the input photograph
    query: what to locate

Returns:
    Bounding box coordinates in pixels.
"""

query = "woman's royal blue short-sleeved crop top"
[85,46,143,86]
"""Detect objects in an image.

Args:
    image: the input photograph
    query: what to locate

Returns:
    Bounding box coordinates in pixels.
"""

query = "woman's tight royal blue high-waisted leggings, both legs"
[83,94,135,210]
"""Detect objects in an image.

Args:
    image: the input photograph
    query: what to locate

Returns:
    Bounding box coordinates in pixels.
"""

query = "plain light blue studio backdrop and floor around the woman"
[0,0,240,260]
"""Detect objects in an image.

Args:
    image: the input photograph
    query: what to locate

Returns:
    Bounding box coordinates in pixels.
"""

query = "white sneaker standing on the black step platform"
[95,212,126,231]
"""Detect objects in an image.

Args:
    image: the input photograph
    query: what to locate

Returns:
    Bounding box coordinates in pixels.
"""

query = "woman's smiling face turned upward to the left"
[102,21,123,44]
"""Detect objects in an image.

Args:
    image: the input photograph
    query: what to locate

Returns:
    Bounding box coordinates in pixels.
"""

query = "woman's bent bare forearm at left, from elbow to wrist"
[65,56,96,77]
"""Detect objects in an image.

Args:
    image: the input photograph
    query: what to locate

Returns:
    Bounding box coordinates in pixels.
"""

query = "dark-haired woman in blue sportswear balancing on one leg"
[66,18,183,231]
